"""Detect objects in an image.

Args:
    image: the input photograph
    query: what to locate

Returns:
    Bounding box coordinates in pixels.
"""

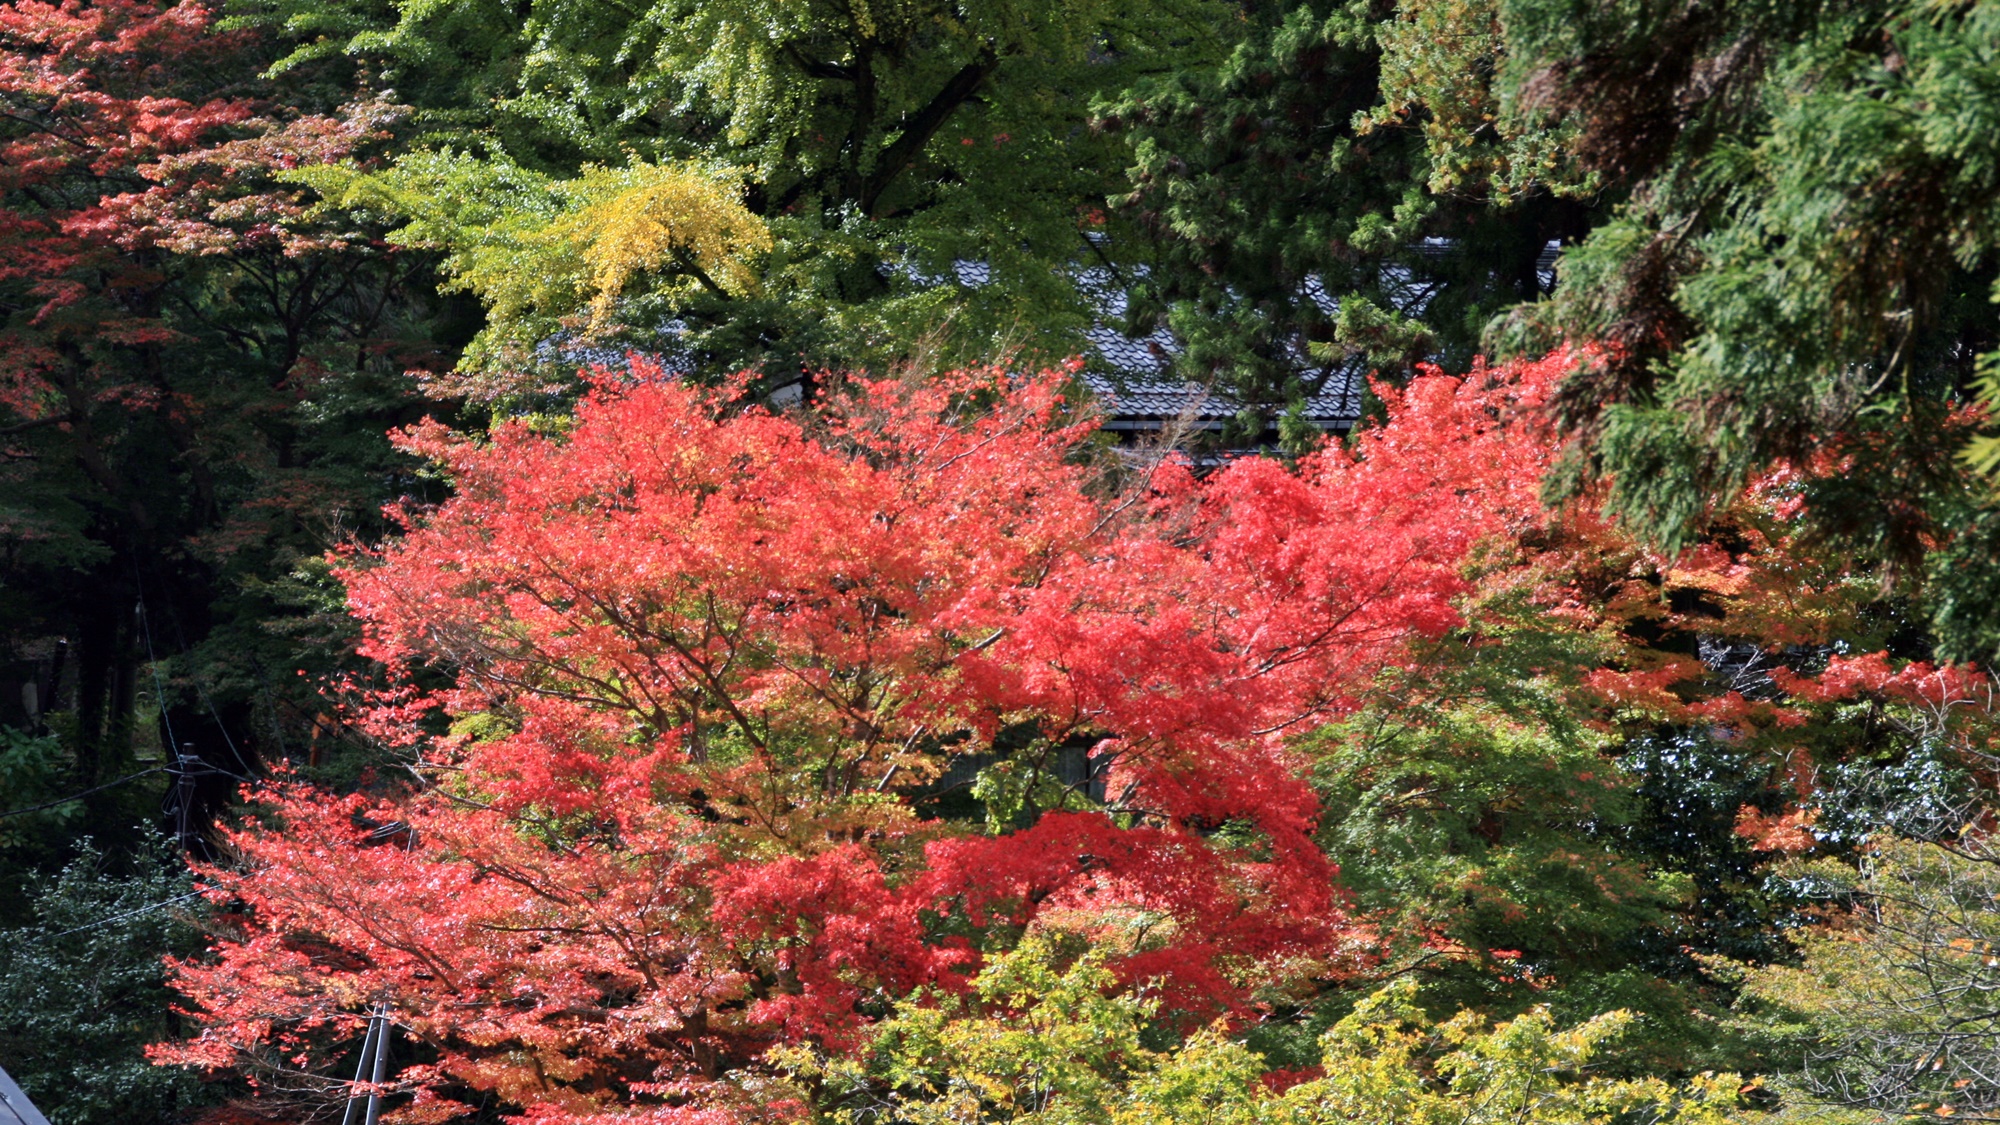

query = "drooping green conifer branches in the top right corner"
[1494,0,2000,659]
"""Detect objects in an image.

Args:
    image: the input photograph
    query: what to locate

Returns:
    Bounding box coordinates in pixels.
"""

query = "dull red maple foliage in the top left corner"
[0,0,390,420]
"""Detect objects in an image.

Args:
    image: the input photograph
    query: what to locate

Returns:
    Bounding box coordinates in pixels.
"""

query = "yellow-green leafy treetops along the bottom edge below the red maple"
[778,935,1756,1125]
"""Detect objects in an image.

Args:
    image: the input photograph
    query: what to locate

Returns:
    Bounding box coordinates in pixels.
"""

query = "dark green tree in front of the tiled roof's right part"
[1100,0,1592,430]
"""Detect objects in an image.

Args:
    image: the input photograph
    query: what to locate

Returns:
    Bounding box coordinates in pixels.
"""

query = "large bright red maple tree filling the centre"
[162,354,1568,1123]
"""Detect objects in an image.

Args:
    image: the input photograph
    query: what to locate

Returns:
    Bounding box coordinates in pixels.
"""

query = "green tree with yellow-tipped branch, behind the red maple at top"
[242,0,1232,386]
